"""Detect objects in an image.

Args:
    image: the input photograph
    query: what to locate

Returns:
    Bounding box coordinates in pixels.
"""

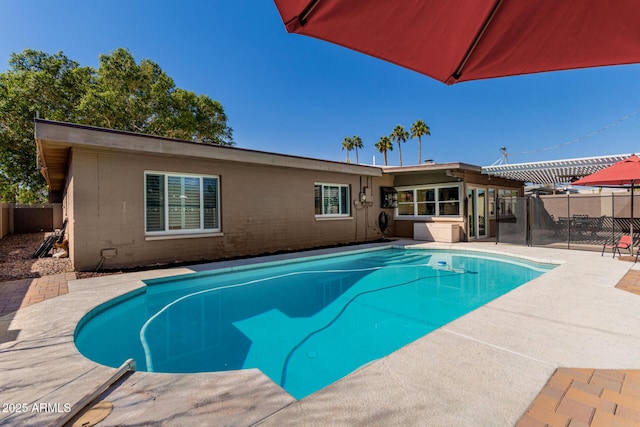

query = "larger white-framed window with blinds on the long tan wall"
[145,172,220,234]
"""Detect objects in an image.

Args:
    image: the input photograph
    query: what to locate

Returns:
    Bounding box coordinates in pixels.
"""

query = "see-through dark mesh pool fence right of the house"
[496,192,640,251]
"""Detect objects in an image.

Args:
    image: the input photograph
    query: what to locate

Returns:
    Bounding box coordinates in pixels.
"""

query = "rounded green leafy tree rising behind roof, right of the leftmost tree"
[79,49,234,145]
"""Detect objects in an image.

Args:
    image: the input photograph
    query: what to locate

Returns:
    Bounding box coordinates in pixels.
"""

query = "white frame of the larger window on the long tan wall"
[143,170,221,237]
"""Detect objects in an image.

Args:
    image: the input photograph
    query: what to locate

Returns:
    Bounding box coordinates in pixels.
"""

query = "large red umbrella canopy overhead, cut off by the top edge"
[274,0,640,84]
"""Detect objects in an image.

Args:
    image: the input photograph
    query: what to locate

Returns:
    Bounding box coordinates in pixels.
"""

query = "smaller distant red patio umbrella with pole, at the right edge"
[573,154,640,253]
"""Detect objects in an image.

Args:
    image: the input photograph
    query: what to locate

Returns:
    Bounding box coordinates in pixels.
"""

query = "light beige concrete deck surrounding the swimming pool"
[0,241,640,426]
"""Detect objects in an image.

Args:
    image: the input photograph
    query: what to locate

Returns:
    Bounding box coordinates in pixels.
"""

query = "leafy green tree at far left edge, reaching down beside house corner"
[0,49,92,203]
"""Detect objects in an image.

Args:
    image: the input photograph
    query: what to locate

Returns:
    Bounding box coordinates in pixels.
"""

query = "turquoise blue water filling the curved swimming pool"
[75,249,553,399]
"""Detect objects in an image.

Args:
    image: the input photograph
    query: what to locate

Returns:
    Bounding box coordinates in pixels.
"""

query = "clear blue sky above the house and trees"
[0,0,640,166]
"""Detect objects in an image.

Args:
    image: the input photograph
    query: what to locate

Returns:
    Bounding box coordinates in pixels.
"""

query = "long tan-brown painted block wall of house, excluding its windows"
[70,148,393,270]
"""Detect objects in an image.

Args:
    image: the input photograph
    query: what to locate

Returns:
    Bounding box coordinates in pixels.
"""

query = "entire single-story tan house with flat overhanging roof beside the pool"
[35,119,523,270]
